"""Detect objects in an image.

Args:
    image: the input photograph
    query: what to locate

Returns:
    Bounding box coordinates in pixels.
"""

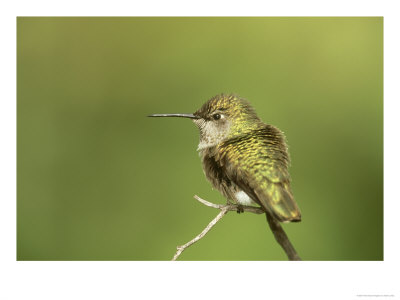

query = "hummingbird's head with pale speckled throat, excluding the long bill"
[193,94,262,150]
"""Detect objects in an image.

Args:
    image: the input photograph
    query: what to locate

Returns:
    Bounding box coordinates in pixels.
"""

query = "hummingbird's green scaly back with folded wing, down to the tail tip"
[216,125,301,222]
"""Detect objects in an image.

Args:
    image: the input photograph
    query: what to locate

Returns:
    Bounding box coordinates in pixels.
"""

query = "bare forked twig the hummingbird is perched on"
[172,195,301,260]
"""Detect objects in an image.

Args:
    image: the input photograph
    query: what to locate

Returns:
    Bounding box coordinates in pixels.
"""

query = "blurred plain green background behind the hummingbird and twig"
[17,17,383,260]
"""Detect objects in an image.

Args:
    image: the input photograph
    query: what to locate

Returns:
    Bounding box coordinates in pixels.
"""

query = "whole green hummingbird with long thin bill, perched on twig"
[150,94,301,222]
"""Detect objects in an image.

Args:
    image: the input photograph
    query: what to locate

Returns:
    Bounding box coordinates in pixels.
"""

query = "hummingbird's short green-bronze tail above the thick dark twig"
[255,183,301,223]
